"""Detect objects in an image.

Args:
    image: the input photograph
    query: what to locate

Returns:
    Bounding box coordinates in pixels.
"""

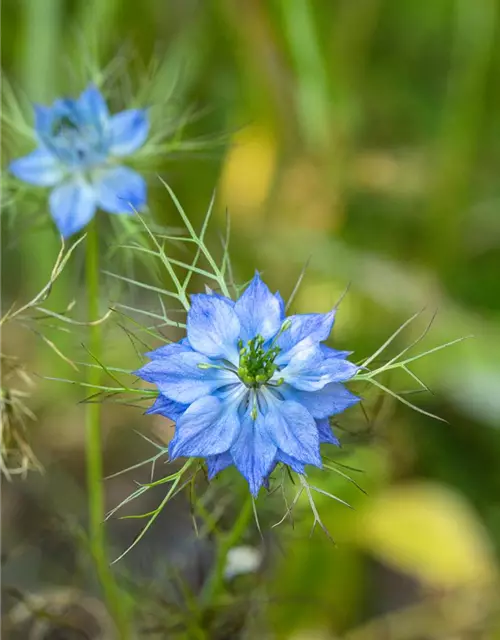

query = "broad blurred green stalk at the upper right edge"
[427,0,499,276]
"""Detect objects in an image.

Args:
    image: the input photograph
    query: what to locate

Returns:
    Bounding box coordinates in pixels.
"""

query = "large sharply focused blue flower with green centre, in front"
[136,274,359,495]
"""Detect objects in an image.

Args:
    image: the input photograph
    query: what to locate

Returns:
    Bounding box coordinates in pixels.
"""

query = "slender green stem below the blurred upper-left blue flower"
[86,218,130,640]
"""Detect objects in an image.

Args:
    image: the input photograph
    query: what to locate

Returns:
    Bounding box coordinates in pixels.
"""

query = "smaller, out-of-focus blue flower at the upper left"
[10,85,149,238]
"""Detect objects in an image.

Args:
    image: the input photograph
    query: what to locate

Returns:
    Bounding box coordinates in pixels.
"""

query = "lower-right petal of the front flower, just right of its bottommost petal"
[265,401,321,466]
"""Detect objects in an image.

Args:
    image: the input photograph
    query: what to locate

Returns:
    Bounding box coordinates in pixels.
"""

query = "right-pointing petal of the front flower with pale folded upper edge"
[280,338,359,391]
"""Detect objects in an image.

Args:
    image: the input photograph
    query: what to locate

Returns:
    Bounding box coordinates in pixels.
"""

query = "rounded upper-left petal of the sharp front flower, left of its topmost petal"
[187,293,240,365]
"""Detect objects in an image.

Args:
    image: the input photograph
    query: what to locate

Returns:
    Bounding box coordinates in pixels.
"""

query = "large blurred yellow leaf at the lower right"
[357,482,495,587]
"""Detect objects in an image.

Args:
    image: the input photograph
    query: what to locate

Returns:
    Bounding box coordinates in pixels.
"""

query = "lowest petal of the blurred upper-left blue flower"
[49,180,96,238]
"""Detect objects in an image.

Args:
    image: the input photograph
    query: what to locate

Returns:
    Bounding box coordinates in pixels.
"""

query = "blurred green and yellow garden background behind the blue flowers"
[0,0,500,640]
